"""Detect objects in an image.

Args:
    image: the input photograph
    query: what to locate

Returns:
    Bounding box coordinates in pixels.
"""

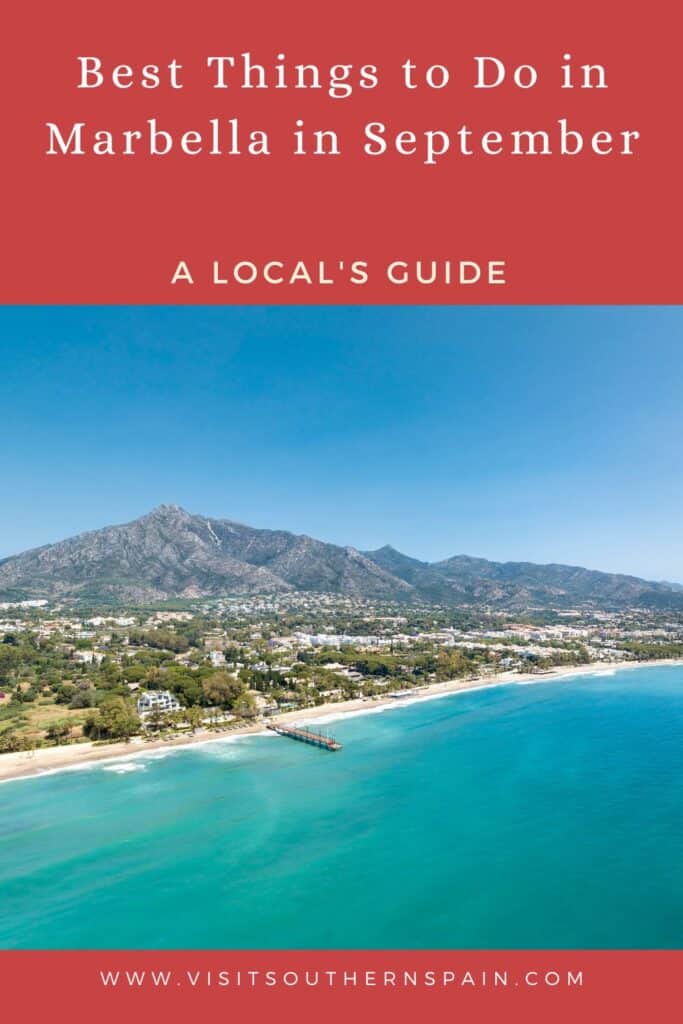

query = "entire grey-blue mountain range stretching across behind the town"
[0,505,683,610]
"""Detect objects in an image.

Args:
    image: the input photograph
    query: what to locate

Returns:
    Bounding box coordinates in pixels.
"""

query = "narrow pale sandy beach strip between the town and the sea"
[0,658,683,783]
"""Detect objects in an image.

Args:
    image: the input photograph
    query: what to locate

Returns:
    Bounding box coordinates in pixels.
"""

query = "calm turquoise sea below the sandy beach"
[0,666,683,948]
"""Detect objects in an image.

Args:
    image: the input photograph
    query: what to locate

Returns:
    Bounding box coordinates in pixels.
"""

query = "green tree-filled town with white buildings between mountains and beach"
[0,593,683,752]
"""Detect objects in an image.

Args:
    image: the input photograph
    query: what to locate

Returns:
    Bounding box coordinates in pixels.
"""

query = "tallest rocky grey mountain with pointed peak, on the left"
[0,505,410,602]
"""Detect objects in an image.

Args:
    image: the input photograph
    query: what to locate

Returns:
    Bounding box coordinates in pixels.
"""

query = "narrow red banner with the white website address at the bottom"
[0,950,683,1024]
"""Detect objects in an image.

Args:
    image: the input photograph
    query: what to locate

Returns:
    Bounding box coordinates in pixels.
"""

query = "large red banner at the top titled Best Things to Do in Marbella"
[0,0,682,303]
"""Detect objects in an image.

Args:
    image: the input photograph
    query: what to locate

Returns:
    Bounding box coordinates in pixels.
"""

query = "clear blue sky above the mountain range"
[0,306,683,581]
